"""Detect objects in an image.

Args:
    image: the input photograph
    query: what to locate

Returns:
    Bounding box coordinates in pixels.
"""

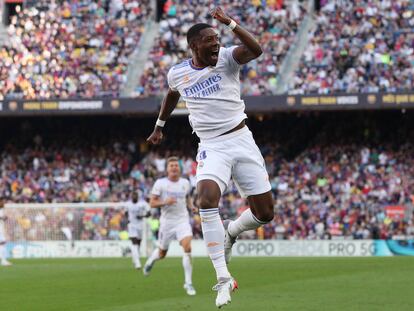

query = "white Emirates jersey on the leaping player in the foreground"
[167,46,247,139]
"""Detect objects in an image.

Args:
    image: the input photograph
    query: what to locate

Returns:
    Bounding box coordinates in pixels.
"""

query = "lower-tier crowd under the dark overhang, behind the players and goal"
[0,113,414,239]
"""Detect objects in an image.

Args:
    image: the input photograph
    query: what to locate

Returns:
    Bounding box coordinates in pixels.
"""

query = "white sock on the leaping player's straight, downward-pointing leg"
[200,208,231,279]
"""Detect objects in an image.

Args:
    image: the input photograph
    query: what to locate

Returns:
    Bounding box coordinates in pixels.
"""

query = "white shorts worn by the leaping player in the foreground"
[197,126,272,197]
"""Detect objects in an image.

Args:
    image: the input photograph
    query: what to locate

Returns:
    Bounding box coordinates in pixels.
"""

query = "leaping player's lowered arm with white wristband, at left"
[147,89,180,145]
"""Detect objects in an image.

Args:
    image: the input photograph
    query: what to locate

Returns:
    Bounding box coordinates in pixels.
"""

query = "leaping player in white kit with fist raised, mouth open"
[148,7,274,307]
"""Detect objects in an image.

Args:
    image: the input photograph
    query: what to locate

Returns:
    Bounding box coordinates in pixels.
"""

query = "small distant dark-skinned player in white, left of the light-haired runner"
[127,192,150,269]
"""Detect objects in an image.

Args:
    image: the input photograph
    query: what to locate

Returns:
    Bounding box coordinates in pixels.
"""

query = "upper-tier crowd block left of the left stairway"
[0,0,151,100]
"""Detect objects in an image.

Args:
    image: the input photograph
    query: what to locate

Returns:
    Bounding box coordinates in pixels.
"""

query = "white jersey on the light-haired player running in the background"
[151,177,191,225]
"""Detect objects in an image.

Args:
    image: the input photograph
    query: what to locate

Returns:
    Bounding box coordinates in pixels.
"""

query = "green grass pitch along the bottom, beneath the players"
[0,257,414,311]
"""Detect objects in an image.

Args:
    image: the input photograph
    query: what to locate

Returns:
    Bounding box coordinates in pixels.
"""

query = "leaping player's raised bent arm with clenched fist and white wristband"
[210,7,263,64]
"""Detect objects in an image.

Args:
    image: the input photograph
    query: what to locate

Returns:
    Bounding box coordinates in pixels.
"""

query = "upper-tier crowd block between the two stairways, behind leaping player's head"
[135,0,304,96]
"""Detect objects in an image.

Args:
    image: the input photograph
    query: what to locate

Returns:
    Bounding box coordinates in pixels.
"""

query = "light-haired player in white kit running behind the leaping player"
[143,157,196,296]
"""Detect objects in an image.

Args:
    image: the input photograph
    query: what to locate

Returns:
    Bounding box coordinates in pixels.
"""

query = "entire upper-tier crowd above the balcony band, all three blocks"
[0,0,414,100]
